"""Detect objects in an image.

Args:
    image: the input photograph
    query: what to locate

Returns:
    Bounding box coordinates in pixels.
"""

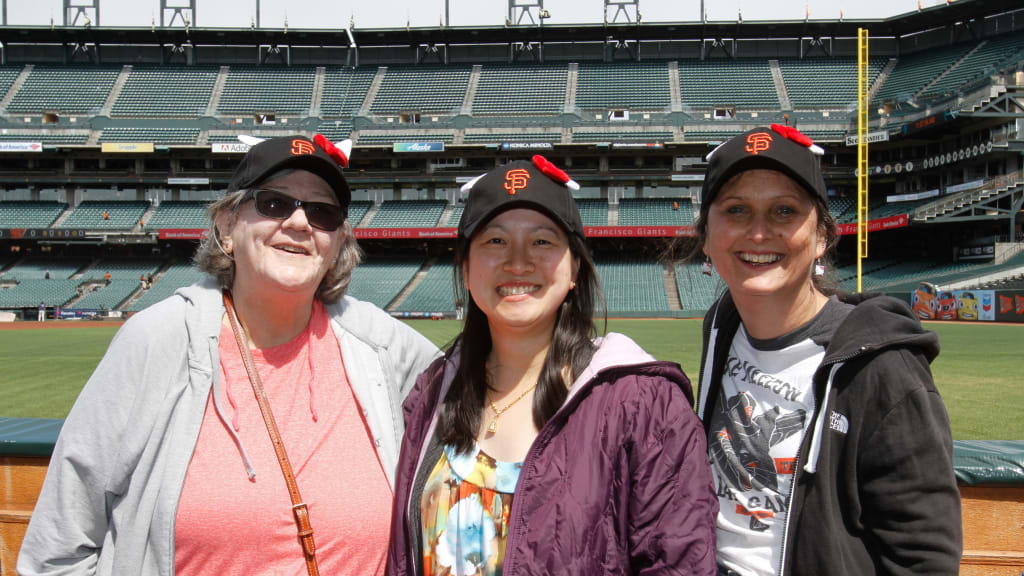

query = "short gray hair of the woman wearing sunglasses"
[193,190,362,304]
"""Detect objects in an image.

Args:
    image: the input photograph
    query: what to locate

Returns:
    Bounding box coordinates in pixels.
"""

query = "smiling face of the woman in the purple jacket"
[462,208,580,333]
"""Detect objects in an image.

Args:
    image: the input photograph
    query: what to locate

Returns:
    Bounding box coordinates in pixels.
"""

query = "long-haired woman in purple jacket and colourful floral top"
[388,156,718,576]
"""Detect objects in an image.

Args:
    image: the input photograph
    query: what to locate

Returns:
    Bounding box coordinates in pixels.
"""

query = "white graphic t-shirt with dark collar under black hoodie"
[708,299,853,576]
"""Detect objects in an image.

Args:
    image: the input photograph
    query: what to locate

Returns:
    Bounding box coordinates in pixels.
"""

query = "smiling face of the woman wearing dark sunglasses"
[217,170,343,299]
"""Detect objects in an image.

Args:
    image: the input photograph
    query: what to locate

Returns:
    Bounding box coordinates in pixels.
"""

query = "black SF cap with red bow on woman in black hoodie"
[700,124,828,203]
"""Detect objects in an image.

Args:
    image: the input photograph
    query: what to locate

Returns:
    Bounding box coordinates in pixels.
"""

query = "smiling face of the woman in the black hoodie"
[703,169,826,302]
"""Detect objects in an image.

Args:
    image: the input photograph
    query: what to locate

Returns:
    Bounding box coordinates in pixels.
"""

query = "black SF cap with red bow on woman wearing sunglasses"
[227,134,352,211]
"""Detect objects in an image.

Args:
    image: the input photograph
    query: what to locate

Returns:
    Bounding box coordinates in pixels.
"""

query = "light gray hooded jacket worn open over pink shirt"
[17,279,438,576]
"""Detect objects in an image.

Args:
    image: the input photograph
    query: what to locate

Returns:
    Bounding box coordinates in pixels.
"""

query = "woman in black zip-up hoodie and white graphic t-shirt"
[697,125,962,576]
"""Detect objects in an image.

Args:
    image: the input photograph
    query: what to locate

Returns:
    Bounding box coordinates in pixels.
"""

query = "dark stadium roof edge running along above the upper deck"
[0,0,1013,47]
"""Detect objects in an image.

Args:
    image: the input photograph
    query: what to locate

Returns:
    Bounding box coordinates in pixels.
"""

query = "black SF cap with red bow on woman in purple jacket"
[459,155,585,241]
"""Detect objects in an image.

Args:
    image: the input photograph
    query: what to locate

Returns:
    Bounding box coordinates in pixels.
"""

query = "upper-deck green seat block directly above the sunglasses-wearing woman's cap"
[217,66,316,115]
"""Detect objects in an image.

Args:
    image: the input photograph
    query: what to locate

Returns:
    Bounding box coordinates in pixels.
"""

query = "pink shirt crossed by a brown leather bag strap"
[174,302,392,576]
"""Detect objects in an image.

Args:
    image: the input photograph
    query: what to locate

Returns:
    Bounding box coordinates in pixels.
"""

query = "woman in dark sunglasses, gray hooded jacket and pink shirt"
[17,136,437,575]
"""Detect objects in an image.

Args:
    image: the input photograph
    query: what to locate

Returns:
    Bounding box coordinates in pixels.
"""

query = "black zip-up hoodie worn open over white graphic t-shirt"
[697,293,963,576]
